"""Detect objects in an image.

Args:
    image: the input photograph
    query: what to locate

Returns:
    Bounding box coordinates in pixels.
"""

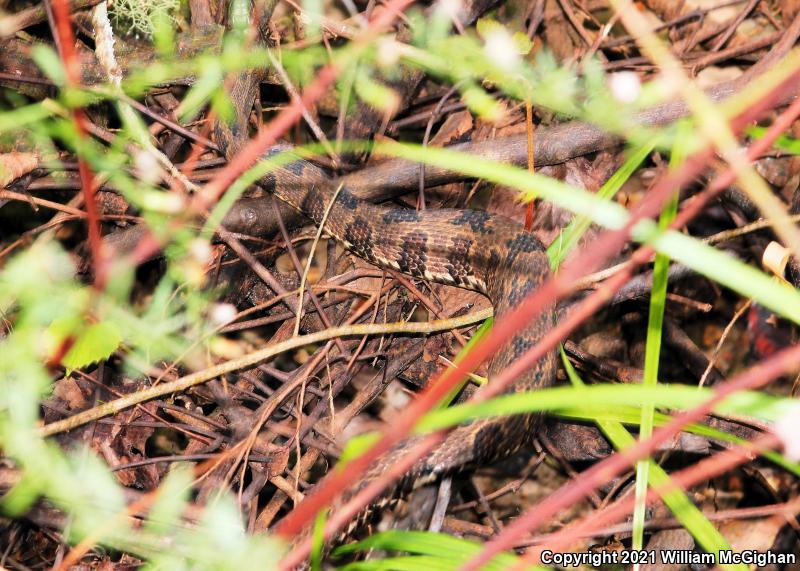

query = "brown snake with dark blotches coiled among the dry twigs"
[215,73,557,536]
